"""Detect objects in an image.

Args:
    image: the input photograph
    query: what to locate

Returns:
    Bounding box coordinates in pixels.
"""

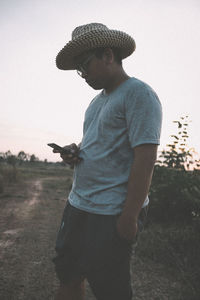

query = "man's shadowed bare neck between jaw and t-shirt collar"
[104,69,130,94]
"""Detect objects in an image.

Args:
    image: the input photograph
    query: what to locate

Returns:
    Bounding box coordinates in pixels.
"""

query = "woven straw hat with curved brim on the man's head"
[56,23,135,70]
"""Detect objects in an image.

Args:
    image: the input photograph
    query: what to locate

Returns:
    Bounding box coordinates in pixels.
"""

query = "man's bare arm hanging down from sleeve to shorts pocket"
[117,144,158,240]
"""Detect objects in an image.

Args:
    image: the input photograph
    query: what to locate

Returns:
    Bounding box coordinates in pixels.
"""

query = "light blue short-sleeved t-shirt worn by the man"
[69,78,162,215]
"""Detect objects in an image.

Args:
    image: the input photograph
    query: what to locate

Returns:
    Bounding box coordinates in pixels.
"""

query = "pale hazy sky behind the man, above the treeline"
[0,0,200,161]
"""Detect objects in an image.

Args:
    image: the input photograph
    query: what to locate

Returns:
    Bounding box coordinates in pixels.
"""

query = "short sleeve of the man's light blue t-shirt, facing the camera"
[125,84,162,148]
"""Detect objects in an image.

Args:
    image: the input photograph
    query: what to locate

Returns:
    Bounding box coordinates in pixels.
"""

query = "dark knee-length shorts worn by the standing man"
[53,202,146,300]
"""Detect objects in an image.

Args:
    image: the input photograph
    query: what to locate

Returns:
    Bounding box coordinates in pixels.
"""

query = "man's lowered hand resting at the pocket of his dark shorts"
[117,214,138,242]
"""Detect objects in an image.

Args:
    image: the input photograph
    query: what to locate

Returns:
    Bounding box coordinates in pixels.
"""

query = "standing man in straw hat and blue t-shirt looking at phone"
[54,23,162,300]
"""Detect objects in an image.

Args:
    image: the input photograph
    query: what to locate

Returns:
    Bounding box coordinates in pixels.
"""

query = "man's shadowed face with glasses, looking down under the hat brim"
[76,51,108,90]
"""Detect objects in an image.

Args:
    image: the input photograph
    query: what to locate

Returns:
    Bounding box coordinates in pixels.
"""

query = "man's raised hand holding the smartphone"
[53,143,81,167]
